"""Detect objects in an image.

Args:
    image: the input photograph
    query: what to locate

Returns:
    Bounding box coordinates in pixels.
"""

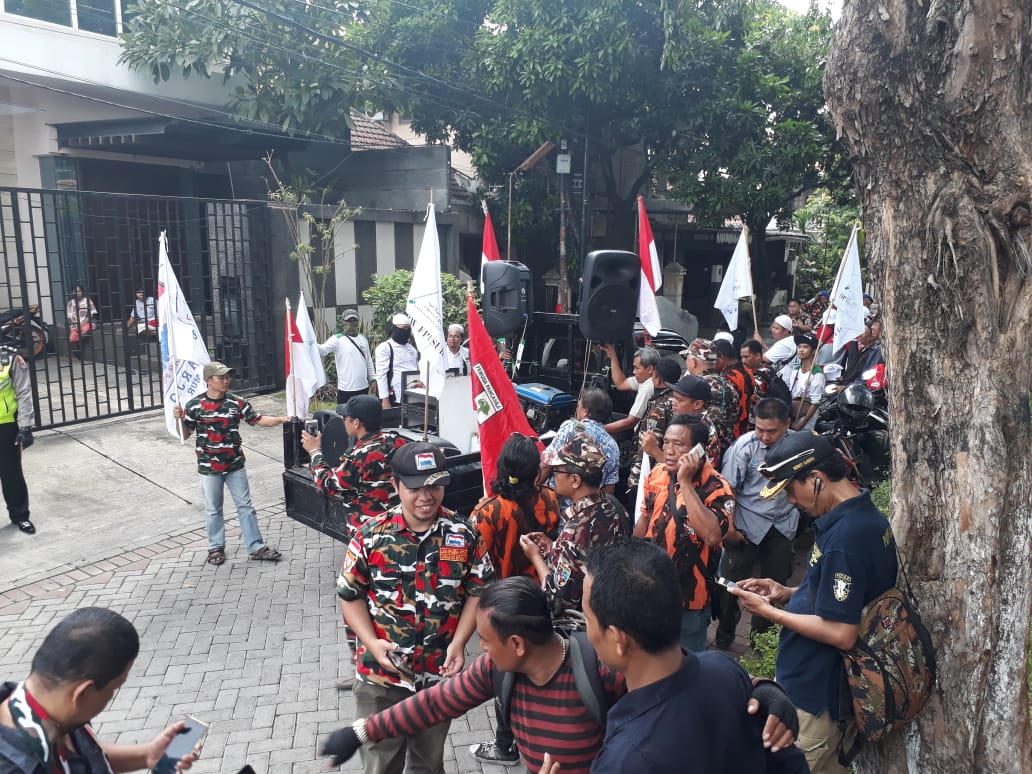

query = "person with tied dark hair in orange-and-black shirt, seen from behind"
[472,433,559,582]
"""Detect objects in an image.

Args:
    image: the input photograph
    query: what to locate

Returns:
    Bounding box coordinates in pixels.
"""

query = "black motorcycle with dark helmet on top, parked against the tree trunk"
[814,373,892,488]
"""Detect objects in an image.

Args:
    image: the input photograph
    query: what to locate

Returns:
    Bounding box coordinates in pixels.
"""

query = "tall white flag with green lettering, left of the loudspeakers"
[405,203,445,397]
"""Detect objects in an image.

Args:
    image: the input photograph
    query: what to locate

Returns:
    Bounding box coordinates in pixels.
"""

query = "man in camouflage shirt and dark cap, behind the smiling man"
[301,395,406,530]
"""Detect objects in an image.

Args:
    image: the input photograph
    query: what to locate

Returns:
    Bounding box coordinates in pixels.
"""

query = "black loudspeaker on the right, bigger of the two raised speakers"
[577,250,642,342]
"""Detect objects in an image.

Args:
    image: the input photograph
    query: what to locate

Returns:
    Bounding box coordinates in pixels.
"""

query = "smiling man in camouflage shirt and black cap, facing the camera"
[336,443,494,774]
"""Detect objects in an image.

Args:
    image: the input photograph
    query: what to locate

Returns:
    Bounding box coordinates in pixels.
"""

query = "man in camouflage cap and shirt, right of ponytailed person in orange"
[520,432,632,622]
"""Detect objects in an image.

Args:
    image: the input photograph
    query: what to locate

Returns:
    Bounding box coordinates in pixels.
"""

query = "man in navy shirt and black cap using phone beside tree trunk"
[732,432,897,774]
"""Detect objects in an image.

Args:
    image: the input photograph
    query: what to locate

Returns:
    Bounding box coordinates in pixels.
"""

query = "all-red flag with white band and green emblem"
[466,296,544,494]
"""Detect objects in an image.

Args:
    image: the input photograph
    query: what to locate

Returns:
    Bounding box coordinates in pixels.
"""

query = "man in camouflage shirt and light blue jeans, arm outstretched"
[172,362,290,565]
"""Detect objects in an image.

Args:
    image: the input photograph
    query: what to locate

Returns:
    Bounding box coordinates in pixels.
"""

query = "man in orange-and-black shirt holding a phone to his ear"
[635,414,735,651]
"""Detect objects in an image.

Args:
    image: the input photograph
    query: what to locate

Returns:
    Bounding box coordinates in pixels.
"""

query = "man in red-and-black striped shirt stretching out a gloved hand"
[322,576,795,774]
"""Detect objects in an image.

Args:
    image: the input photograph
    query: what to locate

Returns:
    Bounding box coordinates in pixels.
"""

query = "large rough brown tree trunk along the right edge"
[825,0,1032,774]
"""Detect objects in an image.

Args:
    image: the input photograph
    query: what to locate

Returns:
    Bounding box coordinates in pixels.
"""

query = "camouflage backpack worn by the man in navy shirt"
[842,582,936,742]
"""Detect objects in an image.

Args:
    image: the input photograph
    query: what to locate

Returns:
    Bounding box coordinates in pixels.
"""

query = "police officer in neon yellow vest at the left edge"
[0,347,36,535]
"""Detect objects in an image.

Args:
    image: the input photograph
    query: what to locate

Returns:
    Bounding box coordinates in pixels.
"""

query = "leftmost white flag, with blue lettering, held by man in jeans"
[158,231,212,441]
